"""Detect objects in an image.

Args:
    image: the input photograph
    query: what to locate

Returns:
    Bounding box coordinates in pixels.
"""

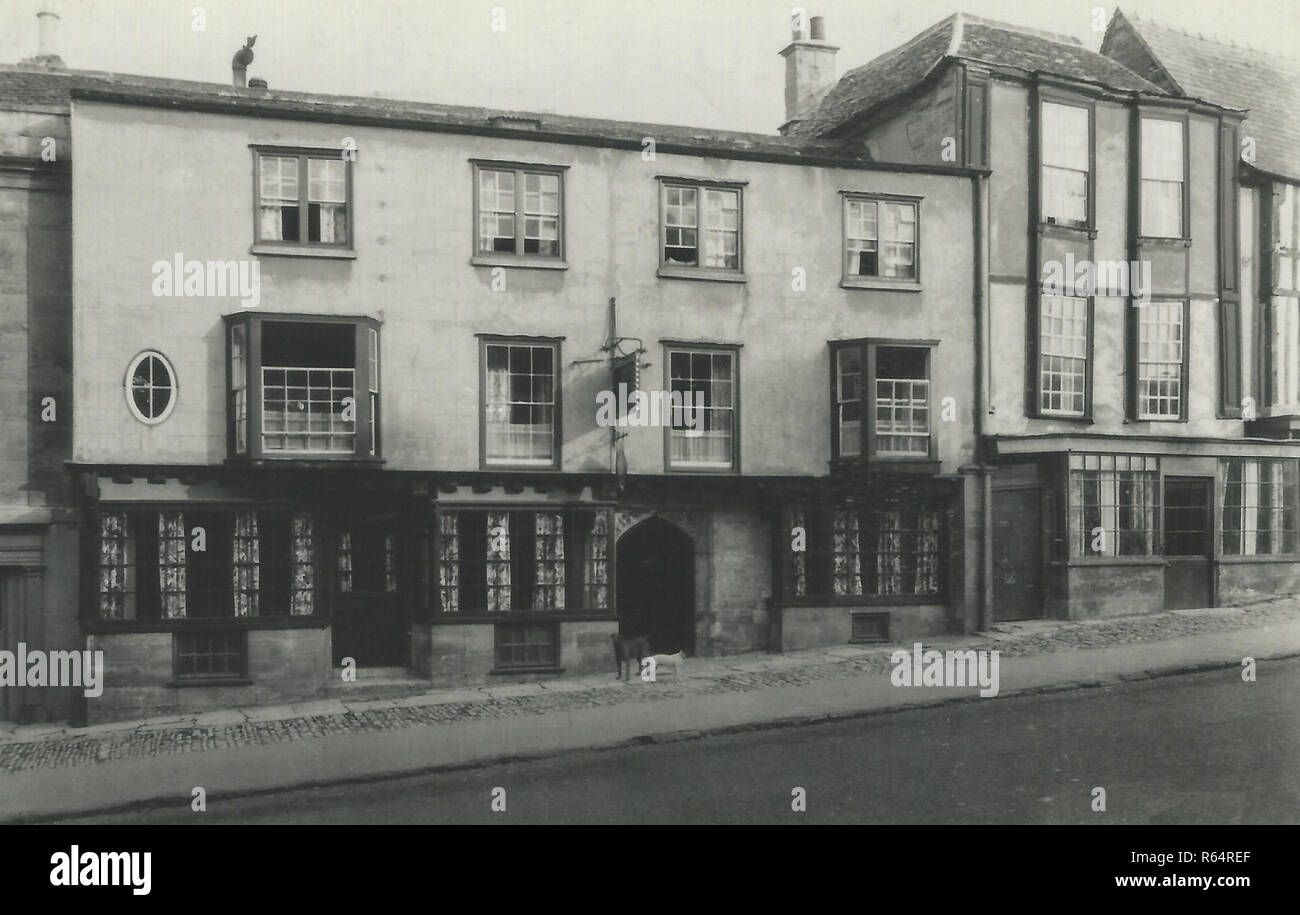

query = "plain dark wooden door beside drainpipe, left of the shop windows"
[993,489,1043,623]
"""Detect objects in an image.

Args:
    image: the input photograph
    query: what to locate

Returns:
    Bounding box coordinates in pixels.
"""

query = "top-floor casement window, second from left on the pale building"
[475,161,564,261]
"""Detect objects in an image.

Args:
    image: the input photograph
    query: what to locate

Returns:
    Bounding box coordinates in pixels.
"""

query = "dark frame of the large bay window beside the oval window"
[222,311,384,463]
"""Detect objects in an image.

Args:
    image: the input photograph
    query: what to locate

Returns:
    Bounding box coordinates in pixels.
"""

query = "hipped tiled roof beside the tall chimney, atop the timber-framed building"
[790,13,1166,136]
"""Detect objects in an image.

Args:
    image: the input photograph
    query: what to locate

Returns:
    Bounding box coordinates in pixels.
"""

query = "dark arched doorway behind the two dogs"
[618,517,696,655]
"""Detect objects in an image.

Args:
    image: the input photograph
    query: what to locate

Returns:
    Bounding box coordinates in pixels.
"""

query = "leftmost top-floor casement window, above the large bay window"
[254,147,352,248]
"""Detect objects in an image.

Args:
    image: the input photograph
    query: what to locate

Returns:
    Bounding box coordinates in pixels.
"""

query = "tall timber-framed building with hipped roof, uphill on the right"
[784,14,1300,621]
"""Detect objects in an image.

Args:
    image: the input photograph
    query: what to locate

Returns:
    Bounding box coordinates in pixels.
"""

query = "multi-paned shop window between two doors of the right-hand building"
[1067,454,1160,556]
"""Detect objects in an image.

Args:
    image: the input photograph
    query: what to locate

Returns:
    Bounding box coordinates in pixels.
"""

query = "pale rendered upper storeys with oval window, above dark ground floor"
[0,64,980,476]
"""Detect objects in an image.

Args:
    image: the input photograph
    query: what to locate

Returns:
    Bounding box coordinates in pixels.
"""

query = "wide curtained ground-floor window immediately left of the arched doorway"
[429,508,614,616]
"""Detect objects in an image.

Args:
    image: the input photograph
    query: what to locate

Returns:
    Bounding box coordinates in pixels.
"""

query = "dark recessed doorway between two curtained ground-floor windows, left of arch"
[333,522,411,667]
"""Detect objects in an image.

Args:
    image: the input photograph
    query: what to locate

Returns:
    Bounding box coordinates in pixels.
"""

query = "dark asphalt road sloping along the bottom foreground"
[58,659,1300,824]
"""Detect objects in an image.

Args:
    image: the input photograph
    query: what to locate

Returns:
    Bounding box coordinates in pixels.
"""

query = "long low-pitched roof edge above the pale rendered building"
[0,64,904,170]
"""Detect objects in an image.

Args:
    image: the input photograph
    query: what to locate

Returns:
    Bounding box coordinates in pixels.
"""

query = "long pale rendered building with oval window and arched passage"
[0,12,985,720]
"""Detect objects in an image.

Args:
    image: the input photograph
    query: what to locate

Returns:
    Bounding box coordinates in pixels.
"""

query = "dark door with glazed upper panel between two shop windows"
[1164,477,1214,610]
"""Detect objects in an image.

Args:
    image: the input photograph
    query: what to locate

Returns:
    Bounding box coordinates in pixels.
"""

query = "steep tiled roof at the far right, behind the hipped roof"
[1102,10,1300,179]
